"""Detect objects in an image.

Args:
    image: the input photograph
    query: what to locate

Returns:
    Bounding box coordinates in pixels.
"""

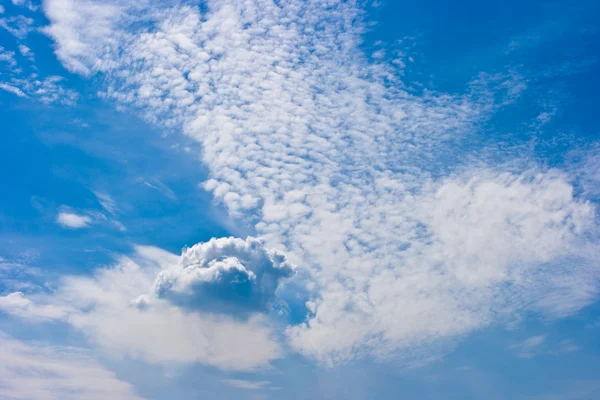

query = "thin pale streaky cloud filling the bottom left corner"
[0,331,142,400]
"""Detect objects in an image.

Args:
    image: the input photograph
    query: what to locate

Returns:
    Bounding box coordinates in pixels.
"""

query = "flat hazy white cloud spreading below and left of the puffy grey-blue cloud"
[0,242,282,370]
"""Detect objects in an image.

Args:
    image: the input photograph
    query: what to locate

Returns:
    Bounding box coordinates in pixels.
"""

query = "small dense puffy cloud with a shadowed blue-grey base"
[137,237,293,314]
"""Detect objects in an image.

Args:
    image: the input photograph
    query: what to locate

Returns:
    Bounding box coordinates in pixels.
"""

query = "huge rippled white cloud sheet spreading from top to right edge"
[45,0,599,363]
